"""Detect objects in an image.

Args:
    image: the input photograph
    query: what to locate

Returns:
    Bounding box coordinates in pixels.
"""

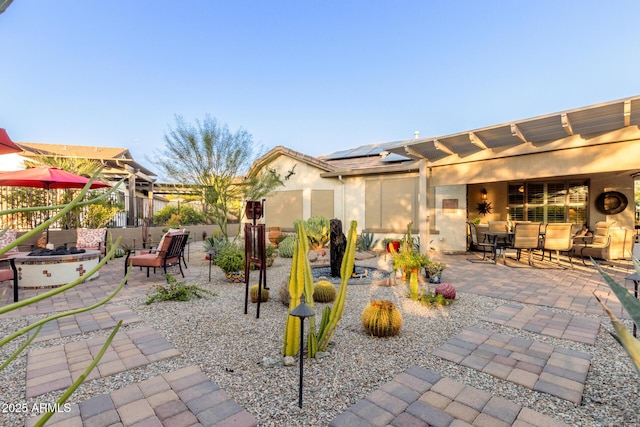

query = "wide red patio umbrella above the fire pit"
[0,166,110,190]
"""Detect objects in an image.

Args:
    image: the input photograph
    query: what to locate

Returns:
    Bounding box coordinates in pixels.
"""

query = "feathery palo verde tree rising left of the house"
[151,115,282,240]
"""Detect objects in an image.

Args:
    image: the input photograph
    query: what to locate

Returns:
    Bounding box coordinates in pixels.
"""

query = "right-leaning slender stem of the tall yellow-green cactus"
[316,221,358,357]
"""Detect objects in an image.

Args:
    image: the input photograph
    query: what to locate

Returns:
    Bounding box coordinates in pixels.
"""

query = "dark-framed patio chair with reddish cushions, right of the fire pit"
[124,231,189,277]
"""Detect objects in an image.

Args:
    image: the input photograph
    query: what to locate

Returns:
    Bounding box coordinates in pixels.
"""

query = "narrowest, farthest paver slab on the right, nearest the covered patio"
[482,304,600,345]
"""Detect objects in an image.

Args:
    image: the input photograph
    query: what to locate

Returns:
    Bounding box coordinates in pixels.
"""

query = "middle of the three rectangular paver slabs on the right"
[433,326,591,407]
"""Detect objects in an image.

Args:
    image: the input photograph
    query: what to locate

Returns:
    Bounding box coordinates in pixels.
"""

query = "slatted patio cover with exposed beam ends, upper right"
[385,96,640,163]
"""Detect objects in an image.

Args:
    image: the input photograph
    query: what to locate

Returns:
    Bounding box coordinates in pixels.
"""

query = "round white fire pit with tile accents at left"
[13,249,100,289]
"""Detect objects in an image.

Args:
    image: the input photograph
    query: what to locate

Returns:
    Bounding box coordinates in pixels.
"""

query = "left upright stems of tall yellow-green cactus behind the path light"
[283,221,316,356]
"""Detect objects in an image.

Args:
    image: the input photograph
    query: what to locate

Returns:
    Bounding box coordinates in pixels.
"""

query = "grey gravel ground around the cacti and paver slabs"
[0,252,640,426]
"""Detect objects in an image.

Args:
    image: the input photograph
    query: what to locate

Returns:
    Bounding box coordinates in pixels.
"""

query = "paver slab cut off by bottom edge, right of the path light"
[330,366,566,427]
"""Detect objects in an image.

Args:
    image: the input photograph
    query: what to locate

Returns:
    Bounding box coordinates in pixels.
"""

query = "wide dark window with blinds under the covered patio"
[508,181,589,224]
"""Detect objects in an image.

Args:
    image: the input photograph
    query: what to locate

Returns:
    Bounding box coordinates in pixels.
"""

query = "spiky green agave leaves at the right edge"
[591,258,640,375]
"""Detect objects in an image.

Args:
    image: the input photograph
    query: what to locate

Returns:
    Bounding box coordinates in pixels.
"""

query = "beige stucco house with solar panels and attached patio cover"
[248,97,640,258]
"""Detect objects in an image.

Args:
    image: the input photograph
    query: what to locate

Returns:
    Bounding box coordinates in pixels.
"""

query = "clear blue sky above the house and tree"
[0,0,640,172]
